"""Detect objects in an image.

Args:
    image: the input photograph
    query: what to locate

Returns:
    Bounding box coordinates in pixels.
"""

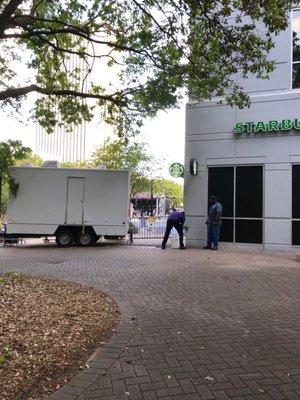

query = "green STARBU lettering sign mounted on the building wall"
[234,118,300,135]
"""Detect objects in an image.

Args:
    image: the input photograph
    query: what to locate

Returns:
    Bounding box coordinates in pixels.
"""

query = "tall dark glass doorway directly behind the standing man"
[208,165,263,244]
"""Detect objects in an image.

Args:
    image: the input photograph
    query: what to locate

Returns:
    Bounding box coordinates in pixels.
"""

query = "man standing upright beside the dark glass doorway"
[203,196,222,250]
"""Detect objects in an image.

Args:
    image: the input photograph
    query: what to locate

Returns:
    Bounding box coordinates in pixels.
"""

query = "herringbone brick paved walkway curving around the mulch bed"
[0,244,300,400]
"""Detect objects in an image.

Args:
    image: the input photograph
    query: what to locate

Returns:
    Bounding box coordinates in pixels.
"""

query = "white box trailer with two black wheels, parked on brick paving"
[5,167,129,247]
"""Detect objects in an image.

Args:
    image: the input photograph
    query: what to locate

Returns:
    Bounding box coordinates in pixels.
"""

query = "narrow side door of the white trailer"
[66,178,85,225]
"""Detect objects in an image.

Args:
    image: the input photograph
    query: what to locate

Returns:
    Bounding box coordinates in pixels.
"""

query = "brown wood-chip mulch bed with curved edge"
[0,273,120,400]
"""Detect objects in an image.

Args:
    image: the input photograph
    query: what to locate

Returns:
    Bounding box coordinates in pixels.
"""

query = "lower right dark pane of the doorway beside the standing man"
[235,219,262,243]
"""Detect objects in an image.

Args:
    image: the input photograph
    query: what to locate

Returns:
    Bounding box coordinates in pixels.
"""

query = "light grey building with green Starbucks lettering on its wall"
[185,10,300,250]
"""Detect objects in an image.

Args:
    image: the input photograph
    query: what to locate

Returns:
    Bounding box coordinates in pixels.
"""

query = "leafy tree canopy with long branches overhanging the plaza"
[0,0,293,132]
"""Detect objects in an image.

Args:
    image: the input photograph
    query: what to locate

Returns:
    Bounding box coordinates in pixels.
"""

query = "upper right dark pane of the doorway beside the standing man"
[235,166,263,218]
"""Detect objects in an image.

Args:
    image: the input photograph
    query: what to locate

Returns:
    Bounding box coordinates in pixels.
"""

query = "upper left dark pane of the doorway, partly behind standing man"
[208,167,234,217]
